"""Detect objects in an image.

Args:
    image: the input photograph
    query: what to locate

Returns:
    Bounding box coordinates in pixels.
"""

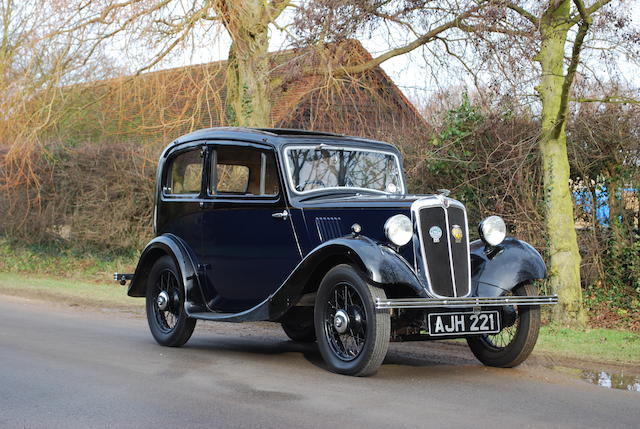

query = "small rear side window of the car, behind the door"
[164,148,202,195]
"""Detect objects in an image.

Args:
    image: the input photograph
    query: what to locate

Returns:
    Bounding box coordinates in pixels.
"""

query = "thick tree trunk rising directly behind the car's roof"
[218,0,271,127]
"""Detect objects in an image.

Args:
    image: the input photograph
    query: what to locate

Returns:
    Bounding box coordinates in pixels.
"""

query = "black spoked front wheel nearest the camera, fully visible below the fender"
[314,265,391,376]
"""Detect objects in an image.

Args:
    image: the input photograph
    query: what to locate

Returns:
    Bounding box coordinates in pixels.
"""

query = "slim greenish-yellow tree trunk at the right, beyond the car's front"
[536,0,586,327]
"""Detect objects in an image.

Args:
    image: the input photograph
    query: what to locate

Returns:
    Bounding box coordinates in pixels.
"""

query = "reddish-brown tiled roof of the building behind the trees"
[57,40,426,141]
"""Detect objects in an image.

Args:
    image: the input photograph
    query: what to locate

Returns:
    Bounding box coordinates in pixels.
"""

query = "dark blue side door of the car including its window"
[199,142,301,312]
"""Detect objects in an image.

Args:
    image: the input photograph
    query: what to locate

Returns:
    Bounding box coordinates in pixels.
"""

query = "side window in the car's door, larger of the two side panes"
[211,146,280,196]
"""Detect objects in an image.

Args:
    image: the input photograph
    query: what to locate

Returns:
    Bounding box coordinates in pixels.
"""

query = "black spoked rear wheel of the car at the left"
[147,255,196,347]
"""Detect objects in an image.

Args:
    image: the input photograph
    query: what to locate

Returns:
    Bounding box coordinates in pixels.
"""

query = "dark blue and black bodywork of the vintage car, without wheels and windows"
[128,128,546,330]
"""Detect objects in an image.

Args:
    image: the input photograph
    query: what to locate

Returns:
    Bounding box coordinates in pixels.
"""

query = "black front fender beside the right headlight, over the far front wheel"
[470,238,547,297]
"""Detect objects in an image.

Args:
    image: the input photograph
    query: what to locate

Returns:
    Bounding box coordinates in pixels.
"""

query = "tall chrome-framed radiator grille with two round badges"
[412,197,471,297]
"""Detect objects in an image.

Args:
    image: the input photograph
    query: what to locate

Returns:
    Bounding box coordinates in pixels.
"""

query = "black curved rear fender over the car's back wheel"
[127,234,209,314]
